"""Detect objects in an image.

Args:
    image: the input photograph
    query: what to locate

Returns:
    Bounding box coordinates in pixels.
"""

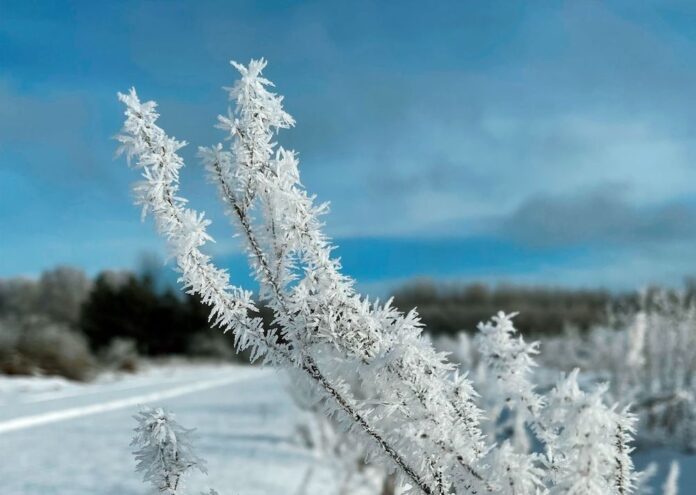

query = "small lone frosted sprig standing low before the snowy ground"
[131,407,206,495]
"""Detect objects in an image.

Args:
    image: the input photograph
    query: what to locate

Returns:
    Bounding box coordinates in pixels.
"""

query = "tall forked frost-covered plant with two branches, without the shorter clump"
[119,61,484,493]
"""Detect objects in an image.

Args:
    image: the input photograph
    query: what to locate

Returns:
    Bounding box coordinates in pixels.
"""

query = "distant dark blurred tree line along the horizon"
[0,262,696,369]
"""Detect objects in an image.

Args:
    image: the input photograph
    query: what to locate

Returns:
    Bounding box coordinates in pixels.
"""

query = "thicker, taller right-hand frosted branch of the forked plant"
[200,61,490,492]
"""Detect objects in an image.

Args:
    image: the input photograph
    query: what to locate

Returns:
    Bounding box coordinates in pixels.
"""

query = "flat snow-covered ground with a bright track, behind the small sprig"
[0,364,696,495]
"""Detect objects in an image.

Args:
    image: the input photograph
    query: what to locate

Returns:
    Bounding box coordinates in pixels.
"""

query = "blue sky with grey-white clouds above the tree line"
[0,0,696,290]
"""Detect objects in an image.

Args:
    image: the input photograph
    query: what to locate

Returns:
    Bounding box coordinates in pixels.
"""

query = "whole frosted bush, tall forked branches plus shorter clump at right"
[118,60,648,495]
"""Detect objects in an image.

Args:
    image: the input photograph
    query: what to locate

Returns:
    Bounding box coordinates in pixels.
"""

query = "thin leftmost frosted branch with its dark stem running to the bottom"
[118,84,434,493]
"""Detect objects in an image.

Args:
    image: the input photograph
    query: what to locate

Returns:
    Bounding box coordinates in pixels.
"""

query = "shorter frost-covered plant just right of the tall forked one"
[476,313,637,495]
